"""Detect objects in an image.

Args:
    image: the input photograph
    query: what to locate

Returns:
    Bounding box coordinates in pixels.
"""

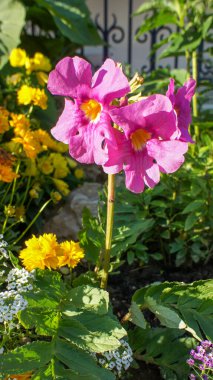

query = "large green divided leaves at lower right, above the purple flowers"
[129,280,213,380]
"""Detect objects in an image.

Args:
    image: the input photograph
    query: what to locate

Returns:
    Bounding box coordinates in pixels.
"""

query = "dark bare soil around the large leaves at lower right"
[108,263,213,380]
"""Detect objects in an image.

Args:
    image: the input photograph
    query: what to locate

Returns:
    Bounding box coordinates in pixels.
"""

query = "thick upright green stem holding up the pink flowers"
[101,174,115,289]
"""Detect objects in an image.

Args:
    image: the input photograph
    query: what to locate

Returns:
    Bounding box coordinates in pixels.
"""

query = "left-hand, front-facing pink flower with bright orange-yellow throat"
[48,57,130,165]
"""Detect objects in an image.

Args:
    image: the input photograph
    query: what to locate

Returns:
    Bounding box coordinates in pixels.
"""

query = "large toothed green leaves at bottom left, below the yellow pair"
[0,271,126,380]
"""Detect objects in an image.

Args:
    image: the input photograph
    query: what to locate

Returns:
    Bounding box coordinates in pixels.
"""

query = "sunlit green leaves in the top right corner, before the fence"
[134,0,213,58]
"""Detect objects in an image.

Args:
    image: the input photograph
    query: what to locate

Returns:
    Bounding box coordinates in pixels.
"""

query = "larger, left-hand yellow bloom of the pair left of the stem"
[20,234,61,271]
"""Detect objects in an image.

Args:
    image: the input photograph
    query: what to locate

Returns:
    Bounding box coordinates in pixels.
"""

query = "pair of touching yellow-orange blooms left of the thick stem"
[20,234,84,271]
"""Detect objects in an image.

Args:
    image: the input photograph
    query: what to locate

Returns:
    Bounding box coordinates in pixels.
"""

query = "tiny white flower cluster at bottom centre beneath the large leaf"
[92,339,133,377]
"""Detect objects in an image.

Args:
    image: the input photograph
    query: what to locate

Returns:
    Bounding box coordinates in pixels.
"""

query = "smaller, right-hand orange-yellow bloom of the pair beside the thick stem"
[58,241,84,268]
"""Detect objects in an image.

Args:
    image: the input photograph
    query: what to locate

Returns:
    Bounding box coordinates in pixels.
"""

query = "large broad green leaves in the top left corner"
[0,0,102,67]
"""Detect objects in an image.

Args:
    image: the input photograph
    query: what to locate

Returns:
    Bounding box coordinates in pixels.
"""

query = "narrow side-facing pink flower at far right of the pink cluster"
[166,78,196,143]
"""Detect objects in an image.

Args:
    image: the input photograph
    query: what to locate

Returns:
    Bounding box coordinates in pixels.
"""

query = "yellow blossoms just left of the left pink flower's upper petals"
[17,84,47,110]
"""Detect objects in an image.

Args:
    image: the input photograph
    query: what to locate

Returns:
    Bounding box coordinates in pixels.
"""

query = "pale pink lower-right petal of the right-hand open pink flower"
[147,139,188,173]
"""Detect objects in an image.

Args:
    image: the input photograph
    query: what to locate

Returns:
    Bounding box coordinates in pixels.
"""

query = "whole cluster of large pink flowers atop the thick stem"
[48,57,196,193]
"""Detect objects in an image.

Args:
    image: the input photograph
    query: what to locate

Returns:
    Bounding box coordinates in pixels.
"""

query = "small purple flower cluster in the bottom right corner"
[187,340,213,380]
